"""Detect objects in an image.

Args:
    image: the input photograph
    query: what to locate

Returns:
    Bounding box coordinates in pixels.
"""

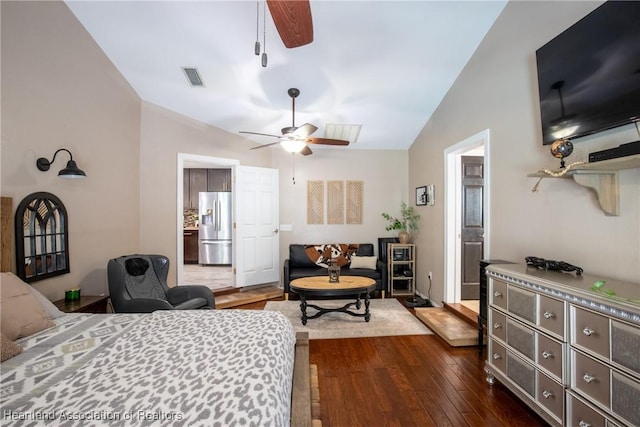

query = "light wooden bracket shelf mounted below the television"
[527,155,640,216]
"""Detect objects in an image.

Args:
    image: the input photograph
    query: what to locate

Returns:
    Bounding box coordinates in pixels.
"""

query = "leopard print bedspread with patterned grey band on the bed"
[0,310,295,426]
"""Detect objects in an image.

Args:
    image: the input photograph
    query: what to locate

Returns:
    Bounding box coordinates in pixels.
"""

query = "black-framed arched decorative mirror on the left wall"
[15,192,69,283]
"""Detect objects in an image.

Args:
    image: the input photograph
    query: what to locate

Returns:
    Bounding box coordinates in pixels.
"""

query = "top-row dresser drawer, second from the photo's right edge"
[571,306,609,360]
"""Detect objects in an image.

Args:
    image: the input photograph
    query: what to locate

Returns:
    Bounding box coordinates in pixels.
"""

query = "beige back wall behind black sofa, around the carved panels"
[273,147,408,259]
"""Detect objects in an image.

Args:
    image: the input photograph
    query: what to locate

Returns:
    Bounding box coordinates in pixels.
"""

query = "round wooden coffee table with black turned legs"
[289,276,376,325]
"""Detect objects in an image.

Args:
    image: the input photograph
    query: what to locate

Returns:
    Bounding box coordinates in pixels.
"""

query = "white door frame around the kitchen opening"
[176,153,240,283]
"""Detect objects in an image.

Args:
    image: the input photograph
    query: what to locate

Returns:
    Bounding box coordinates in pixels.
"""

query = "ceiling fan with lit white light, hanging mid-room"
[240,87,349,156]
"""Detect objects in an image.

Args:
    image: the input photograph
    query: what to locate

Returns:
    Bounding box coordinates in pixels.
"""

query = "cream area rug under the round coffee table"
[264,298,433,339]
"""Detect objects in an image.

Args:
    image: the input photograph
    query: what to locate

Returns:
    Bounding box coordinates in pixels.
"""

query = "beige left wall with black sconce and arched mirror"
[1,1,140,300]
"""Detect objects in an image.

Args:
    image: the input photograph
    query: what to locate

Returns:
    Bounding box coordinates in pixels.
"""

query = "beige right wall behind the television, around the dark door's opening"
[409,1,640,302]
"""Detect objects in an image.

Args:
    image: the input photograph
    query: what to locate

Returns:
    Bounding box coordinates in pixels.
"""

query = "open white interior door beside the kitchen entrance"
[233,166,280,287]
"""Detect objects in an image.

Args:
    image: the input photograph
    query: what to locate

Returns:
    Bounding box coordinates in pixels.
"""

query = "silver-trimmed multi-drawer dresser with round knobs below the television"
[485,264,640,427]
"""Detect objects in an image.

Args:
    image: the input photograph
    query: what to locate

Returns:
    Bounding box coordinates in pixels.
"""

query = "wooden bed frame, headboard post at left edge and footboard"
[0,197,312,427]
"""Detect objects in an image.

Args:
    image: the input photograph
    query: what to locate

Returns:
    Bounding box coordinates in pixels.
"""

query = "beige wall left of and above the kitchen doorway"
[139,102,271,284]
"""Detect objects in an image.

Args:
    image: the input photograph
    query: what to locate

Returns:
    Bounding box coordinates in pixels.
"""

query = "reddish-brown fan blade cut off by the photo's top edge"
[267,0,313,49]
